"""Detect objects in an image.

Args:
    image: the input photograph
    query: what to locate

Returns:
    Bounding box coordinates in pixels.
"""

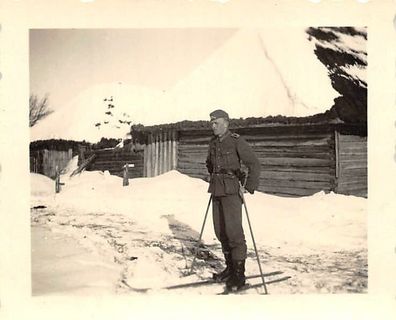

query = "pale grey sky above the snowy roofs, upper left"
[30,28,236,110]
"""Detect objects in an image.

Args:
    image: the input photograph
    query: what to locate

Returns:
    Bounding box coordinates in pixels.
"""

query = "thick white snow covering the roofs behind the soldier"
[31,27,338,142]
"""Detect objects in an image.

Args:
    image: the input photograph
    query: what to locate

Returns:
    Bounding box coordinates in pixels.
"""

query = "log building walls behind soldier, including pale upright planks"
[128,123,367,197]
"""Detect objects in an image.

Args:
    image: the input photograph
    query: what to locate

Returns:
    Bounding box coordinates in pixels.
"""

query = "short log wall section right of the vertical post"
[335,132,367,197]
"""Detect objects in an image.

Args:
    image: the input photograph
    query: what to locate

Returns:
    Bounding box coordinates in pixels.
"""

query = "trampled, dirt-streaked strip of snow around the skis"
[32,205,367,294]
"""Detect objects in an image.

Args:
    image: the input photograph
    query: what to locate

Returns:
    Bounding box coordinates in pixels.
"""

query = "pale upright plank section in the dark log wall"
[143,130,178,177]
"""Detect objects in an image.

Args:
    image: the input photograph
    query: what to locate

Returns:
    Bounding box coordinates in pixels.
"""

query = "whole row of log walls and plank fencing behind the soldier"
[30,122,367,197]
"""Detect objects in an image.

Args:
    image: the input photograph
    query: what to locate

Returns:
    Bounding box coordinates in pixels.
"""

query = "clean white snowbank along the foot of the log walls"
[31,171,366,253]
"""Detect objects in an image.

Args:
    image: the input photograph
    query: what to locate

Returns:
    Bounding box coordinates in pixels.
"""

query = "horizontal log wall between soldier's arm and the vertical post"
[249,132,335,196]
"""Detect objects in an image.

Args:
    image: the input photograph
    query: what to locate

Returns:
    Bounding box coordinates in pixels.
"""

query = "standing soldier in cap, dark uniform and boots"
[206,110,260,289]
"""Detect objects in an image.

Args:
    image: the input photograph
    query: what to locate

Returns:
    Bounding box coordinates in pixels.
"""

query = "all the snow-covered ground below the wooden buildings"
[31,164,367,294]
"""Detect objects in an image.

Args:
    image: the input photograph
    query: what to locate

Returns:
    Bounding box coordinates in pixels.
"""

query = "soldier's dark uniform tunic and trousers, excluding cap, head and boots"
[206,131,260,260]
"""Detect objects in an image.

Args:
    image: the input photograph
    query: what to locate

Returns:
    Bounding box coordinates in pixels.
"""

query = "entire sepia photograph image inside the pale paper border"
[28,25,369,297]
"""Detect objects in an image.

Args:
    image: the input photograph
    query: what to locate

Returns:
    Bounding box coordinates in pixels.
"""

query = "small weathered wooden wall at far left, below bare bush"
[30,149,73,179]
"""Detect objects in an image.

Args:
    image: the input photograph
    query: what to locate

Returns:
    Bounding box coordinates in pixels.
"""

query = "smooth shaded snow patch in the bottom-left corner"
[32,225,120,296]
